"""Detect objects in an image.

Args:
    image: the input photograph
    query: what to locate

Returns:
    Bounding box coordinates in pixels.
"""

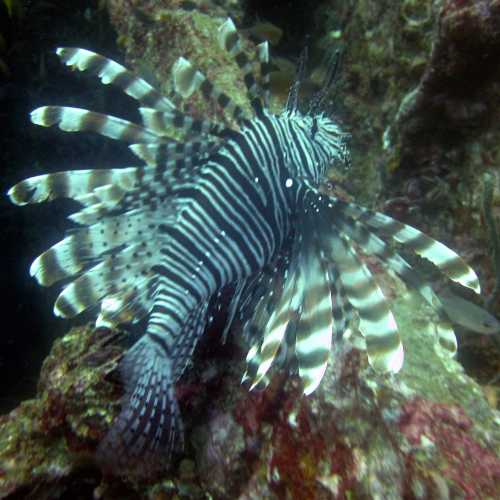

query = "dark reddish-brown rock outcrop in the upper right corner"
[398,0,500,168]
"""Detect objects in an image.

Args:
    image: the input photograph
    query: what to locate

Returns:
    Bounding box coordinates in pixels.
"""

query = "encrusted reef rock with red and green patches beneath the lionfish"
[0,294,500,500]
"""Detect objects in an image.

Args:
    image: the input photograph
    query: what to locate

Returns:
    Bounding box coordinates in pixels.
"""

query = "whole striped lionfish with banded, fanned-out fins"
[8,19,480,469]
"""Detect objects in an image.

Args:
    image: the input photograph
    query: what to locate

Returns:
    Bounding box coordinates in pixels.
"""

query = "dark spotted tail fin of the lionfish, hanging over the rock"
[97,337,183,475]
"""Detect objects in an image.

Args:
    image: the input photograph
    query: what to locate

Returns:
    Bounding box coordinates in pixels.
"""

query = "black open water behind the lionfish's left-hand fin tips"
[0,0,320,414]
